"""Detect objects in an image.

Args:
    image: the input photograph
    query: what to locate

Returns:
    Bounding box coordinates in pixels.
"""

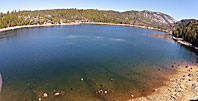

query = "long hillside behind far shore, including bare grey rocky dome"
[0,9,176,30]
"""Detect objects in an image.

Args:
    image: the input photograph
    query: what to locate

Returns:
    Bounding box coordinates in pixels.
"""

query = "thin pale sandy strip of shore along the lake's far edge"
[0,22,172,34]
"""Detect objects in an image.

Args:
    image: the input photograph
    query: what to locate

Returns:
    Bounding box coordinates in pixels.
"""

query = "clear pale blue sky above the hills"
[0,0,198,20]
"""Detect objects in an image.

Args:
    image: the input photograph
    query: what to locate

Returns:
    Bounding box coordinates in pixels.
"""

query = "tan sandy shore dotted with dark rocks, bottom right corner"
[129,65,198,101]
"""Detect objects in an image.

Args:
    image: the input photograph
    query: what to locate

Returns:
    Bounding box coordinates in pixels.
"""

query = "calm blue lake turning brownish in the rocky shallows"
[0,25,198,101]
